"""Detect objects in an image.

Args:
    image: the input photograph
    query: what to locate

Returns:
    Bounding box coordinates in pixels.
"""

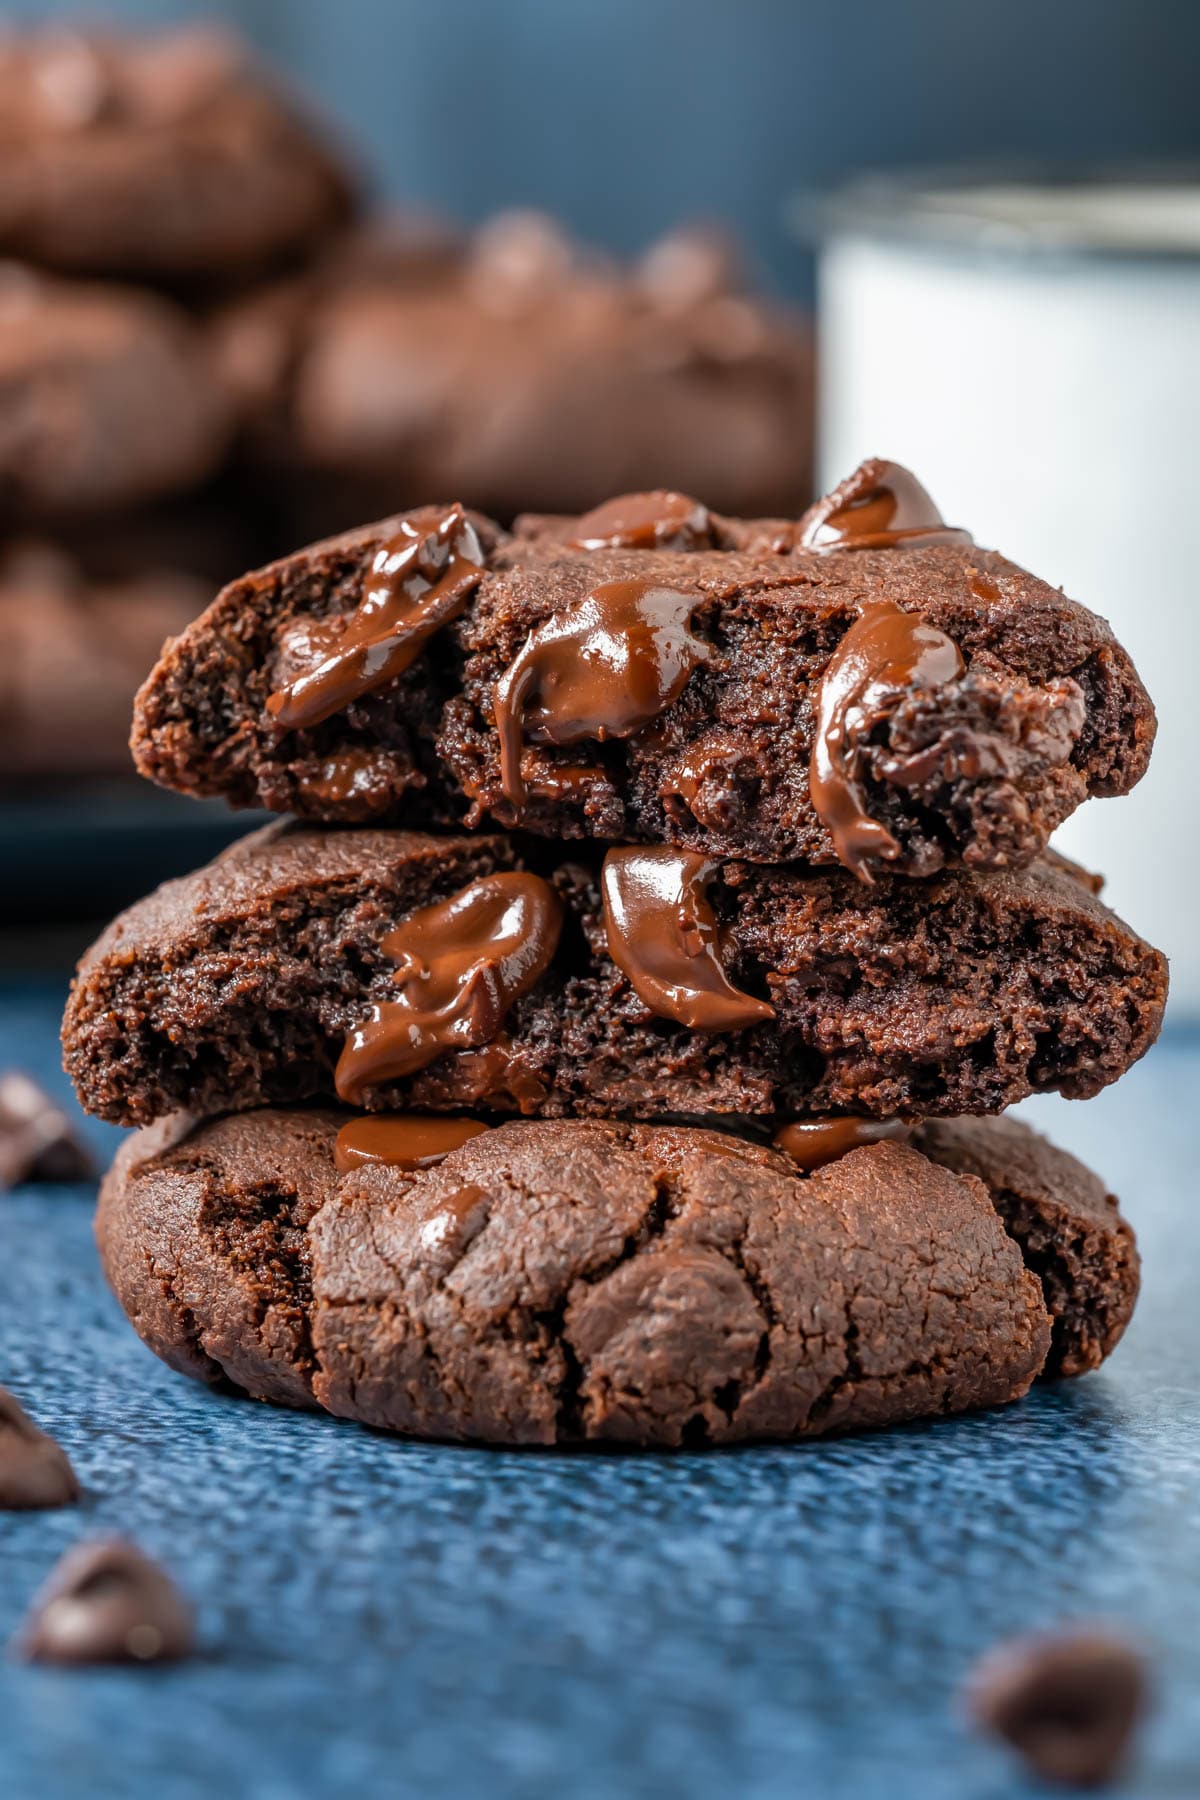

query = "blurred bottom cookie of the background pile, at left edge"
[0,542,203,778]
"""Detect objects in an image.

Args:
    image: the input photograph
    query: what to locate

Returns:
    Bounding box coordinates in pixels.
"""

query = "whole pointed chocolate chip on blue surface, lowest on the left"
[18,1537,194,1663]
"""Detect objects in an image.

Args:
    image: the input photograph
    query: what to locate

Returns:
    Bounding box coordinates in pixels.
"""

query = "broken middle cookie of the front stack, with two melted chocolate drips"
[63,826,1166,1123]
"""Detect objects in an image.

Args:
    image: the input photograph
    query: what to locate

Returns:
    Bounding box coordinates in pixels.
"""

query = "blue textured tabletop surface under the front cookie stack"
[0,985,1200,1800]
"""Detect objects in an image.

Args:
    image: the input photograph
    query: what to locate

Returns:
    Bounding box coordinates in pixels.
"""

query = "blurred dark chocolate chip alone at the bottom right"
[968,1631,1146,1787]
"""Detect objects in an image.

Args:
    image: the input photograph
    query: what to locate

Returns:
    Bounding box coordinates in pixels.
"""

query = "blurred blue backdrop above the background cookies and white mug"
[0,0,1200,290]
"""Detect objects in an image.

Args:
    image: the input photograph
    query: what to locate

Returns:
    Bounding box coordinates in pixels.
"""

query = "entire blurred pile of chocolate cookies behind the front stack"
[0,17,811,781]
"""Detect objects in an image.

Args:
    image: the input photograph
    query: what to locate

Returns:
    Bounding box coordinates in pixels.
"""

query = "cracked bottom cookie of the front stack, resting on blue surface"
[97,1112,1137,1445]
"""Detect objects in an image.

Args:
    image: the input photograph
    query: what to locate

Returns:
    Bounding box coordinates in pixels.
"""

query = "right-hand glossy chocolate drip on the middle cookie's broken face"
[601,846,775,1031]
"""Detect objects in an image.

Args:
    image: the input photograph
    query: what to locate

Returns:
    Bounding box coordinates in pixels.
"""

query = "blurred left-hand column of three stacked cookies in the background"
[0,25,351,778]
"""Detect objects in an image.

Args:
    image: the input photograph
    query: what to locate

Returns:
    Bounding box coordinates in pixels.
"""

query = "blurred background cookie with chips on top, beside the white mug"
[216,212,813,536]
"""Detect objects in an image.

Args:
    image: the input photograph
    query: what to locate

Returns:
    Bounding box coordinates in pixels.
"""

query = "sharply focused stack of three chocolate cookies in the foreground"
[65,463,1166,1445]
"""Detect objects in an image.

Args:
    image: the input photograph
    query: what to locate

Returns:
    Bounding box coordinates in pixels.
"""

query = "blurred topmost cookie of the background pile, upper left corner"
[0,25,349,284]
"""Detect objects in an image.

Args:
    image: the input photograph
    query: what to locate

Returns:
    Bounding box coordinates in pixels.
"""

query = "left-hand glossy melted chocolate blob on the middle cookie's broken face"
[335,871,563,1105]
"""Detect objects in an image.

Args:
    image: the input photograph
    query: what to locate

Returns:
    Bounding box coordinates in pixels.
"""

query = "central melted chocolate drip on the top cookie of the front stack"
[493,581,712,812]
